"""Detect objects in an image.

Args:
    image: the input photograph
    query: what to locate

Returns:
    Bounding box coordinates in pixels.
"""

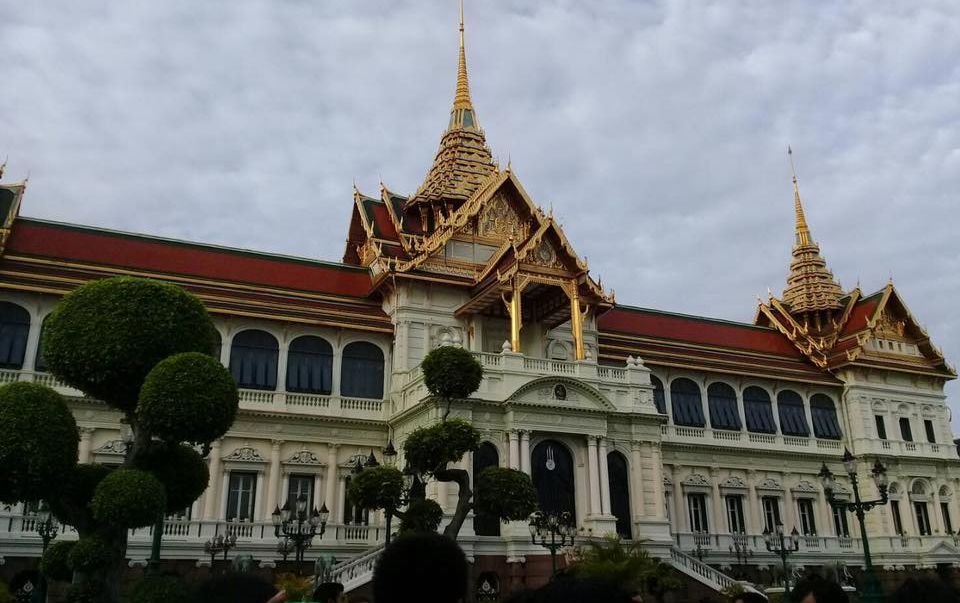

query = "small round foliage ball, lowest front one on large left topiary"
[90,469,166,528]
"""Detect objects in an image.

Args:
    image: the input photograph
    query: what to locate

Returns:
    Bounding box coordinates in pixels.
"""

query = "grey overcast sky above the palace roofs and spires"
[0,0,960,424]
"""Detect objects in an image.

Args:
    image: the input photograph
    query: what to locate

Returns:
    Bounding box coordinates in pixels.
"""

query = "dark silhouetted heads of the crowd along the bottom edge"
[189,533,960,603]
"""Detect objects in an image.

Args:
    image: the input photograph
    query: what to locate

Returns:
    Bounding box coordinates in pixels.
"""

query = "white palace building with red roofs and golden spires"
[0,9,960,600]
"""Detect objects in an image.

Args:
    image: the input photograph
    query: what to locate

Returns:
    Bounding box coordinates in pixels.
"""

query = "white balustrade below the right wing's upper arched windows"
[660,425,843,455]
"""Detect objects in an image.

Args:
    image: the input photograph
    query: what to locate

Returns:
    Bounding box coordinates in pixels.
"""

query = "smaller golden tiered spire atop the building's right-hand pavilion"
[783,147,843,316]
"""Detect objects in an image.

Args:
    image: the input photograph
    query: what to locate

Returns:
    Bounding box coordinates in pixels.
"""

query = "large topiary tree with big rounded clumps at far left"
[0,277,239,602]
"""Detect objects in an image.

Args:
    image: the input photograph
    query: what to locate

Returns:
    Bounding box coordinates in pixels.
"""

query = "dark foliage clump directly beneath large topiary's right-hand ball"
[137,442,210,513]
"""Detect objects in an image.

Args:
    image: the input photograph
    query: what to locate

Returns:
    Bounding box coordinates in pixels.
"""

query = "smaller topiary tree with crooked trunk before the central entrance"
[351,346,537,540]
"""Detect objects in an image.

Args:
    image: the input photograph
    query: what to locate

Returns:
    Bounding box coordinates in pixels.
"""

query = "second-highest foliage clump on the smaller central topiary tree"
[403,418,480,474]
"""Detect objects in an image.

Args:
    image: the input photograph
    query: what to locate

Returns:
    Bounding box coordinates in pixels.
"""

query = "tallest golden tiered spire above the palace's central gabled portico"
[407,0,497,219]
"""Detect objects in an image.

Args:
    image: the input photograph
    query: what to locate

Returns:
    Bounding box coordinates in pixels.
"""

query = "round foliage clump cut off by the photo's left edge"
[0,382,80,503]
